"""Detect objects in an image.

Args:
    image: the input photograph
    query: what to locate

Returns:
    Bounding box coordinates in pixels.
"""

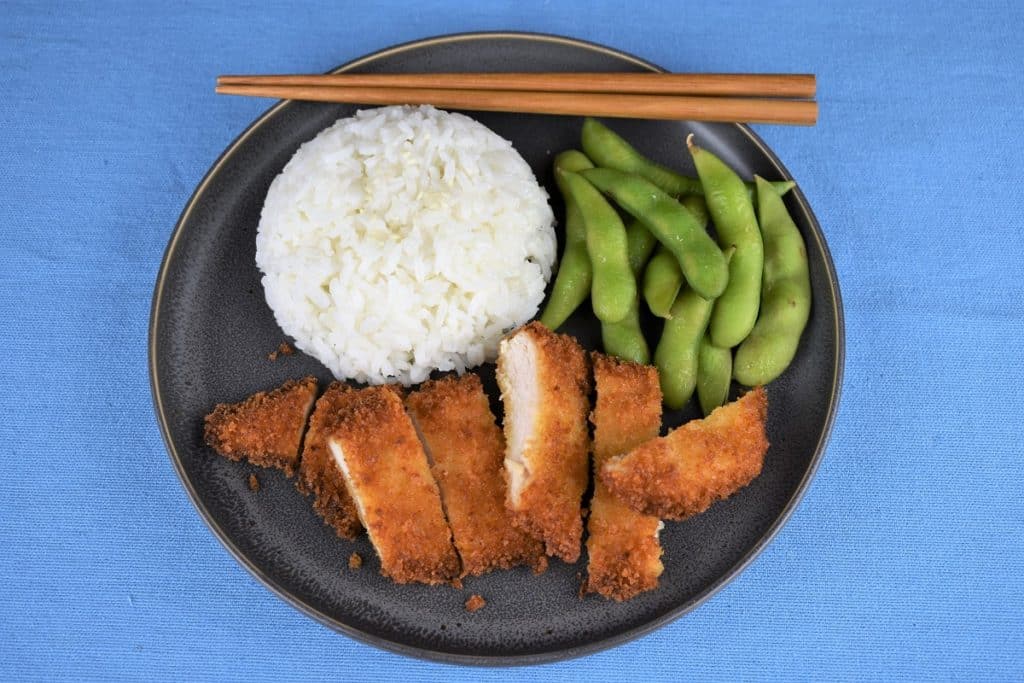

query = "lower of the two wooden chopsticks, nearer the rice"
[216,85,818,126]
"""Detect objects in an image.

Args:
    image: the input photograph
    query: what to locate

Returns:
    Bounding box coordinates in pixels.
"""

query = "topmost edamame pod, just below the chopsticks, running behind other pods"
[580,119,795,198]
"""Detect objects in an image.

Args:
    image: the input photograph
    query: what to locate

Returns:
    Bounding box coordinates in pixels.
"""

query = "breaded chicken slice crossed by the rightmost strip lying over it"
[586,353,664,601]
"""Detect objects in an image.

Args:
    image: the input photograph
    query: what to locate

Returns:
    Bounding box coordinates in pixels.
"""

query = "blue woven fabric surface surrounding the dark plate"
[0,0,1024,681]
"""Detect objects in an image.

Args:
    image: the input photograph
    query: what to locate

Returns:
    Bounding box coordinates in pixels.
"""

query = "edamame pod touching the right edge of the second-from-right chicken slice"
[654,287,712,409]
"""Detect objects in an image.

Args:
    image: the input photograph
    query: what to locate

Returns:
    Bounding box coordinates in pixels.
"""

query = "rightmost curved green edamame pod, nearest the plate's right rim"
[733,177,811,386]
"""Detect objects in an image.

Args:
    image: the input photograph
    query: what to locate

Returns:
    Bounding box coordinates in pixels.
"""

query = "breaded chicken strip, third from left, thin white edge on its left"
[327,386,460,584]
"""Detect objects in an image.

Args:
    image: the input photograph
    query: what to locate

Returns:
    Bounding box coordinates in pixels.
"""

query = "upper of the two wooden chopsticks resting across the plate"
[217,73,817,97]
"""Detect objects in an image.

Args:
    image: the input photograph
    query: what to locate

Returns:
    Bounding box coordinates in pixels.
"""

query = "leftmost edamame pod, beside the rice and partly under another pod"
[541,150,594,330]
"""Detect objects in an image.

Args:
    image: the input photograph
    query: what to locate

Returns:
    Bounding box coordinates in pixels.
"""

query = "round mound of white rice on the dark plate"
[256,106,556,385]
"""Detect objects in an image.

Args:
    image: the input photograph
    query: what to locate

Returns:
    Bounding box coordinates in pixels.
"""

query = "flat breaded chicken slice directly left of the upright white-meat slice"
[406,373,544,575]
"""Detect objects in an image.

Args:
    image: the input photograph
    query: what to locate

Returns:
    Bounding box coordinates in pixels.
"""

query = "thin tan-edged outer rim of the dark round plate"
[148,31,846,667]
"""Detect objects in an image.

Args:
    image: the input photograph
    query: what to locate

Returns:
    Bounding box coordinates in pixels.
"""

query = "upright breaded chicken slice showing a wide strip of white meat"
[498,322,590,563]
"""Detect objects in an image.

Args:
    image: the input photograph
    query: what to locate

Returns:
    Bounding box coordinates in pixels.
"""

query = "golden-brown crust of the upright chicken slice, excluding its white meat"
[497,321,590,563]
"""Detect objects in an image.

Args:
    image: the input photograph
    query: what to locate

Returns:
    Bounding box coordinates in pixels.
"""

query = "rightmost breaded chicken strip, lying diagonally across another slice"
[601,387,768,520]
